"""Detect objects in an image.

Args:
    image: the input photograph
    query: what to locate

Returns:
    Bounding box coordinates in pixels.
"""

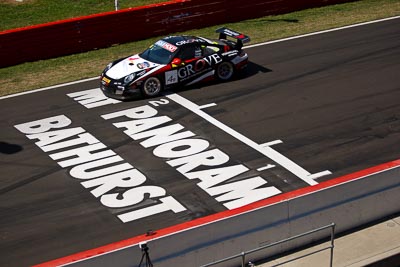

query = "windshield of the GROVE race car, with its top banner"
[139,40,177,64]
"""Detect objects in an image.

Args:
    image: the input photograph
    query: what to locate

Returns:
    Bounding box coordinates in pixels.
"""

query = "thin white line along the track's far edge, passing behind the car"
[0,16,400,100]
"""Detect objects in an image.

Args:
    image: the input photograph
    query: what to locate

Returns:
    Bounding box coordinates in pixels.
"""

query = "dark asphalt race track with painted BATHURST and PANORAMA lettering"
[0,19,400,266]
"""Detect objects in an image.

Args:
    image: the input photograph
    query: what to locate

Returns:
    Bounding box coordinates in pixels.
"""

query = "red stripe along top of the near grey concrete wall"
[33,159,400,267]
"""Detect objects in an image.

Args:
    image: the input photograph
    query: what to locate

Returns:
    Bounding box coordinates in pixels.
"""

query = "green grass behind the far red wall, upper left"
[0,0,167,31]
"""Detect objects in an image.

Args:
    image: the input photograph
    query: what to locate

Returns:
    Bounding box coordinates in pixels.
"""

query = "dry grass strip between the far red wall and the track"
[0,0,400,95]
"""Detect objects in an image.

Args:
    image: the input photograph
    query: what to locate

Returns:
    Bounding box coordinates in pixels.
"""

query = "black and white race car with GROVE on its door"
[100,27,250,100]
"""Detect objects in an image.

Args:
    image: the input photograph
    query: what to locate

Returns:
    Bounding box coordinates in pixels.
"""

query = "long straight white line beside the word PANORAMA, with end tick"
[166,94,331,185]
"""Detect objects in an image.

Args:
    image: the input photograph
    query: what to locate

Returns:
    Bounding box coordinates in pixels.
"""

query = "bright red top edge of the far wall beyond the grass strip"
[0,0,189,35]
